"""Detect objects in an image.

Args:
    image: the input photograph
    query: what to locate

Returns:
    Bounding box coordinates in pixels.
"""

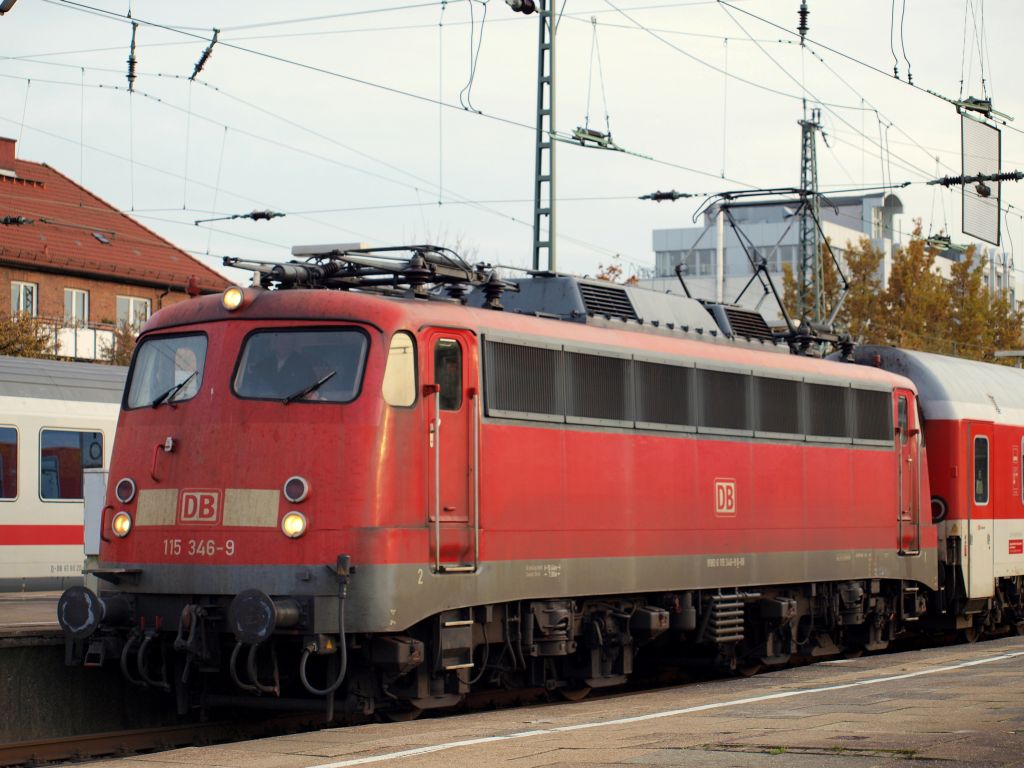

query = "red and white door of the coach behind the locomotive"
[964,421,996,597]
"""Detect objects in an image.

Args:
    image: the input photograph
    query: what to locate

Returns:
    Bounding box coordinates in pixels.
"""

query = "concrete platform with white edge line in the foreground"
[77,638,1024,768]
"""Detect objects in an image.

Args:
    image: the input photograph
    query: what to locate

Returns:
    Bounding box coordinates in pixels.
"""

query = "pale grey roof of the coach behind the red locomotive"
[854,346,1024,425]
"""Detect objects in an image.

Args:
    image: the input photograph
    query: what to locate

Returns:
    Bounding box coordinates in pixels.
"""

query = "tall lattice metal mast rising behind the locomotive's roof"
[534,0,556,271]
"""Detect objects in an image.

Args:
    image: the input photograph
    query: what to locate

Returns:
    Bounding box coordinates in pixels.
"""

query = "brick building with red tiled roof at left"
[0,137,228,359]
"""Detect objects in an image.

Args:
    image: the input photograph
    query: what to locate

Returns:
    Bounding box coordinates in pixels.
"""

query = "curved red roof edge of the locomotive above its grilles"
[143,289,912,389]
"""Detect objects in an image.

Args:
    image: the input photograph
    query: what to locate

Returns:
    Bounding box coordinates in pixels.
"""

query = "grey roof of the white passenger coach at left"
[0,356,128,403]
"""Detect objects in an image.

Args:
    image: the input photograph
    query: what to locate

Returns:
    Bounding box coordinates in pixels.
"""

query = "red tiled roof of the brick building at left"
[0,138,229,293]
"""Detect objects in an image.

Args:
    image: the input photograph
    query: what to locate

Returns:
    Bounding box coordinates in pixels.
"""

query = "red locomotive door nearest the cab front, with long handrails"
[422,329,480,573]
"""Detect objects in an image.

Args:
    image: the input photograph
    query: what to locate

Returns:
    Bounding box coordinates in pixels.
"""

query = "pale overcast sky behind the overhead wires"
[0,0,1024,286]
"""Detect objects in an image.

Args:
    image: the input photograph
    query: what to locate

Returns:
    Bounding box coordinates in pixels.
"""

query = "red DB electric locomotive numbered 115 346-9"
[58,247,941,715]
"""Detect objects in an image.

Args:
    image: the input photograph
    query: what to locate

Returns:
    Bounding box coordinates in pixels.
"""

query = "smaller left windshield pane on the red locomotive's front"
[128,334,206,409]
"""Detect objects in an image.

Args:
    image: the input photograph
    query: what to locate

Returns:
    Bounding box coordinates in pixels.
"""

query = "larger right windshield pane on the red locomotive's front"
[233,329,369,404]
